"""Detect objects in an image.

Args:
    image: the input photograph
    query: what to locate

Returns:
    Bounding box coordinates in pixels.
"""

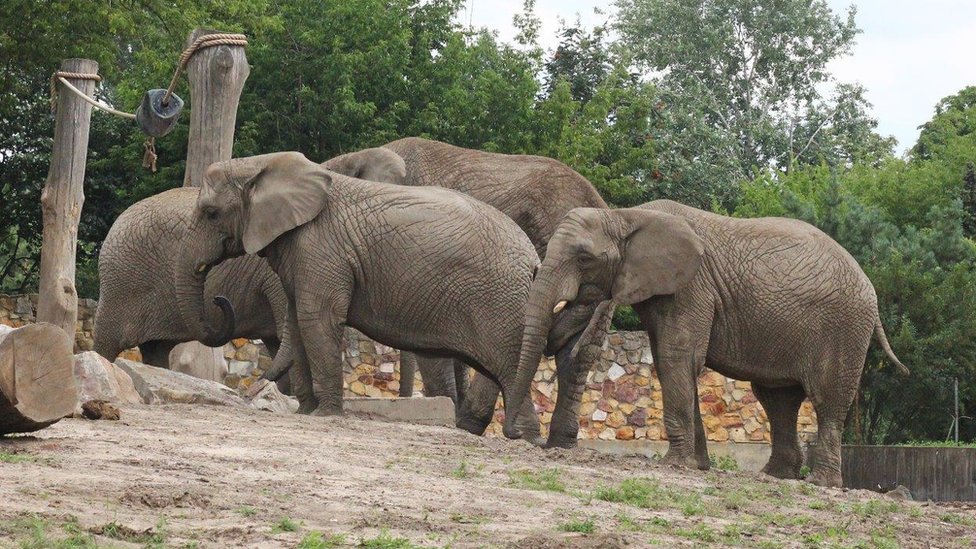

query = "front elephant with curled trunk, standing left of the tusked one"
[176,153,538,440]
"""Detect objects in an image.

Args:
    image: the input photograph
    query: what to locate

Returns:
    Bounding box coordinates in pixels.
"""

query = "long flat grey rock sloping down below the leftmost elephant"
[115,358,249,408]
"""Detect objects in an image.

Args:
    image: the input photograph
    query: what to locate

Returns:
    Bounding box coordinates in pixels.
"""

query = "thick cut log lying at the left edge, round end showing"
[0,322,78,434]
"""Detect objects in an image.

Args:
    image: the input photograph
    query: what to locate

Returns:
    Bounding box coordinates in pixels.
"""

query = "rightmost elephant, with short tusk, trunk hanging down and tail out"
[505,200,908,486]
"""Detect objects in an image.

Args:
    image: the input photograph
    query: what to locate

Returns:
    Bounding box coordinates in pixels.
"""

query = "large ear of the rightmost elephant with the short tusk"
[610,208,705,305]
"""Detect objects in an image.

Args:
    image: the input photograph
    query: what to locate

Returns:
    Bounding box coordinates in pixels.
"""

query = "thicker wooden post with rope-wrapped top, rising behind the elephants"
[183,29,251,187]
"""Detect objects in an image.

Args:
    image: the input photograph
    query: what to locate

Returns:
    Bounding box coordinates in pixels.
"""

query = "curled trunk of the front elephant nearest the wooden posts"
[175,223,236,347]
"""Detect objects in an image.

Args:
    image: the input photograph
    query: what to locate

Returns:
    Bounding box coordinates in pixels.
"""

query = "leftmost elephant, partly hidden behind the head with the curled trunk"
[95,188,289,368]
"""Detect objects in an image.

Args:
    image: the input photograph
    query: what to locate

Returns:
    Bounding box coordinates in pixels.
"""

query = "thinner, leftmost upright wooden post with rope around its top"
[37,59,98,334]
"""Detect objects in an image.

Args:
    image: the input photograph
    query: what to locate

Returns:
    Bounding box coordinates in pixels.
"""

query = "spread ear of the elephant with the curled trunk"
[242,152,332,254]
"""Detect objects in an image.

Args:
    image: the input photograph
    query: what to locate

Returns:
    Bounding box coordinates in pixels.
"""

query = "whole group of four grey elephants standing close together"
[95,138,907,486]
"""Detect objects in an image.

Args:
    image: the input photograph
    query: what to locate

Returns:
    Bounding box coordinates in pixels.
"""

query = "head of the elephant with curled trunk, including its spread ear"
[176,152,332,345]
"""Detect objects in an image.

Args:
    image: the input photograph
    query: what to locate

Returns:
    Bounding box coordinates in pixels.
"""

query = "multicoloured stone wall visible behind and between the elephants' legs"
[0,295,817,442]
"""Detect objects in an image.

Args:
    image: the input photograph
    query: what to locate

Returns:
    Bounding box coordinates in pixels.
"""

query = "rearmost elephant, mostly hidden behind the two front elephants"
[323,137,613,448]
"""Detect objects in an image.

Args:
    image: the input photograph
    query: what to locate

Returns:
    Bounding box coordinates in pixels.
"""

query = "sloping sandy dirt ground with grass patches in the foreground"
[0,405,976,548]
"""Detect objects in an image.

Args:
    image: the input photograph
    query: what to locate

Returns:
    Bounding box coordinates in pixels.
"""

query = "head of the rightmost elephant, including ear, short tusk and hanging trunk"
[505,208,704,438]
